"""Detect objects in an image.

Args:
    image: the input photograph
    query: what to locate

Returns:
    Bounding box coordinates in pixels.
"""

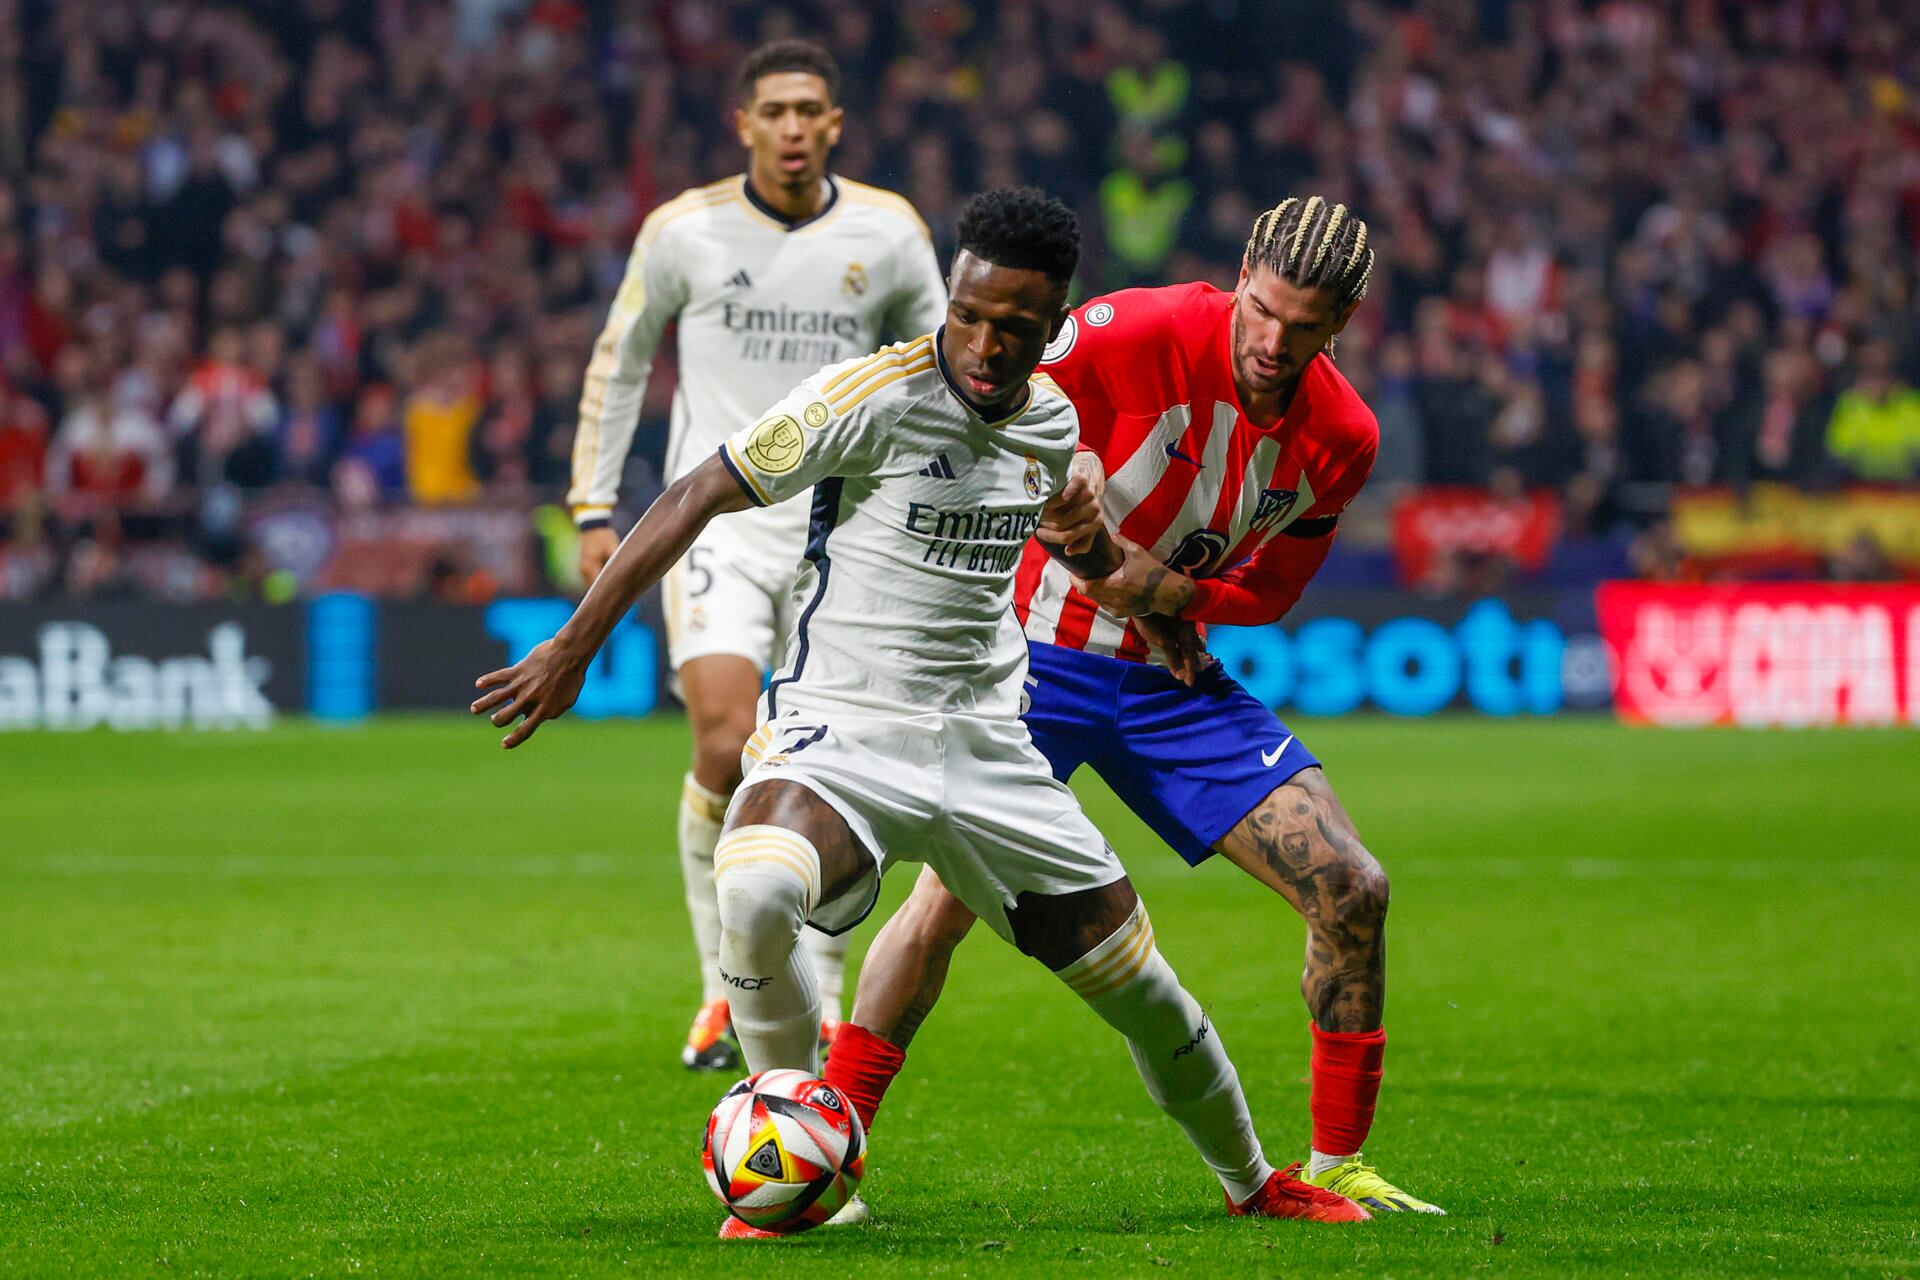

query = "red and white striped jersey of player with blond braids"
[1014,284,1380,662]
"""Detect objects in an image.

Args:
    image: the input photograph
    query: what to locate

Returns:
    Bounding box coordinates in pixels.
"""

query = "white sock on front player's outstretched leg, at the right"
[1060,906,1273,1205]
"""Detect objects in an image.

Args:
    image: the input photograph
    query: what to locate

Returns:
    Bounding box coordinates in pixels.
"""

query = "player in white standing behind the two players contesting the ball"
[568,40,947,1071]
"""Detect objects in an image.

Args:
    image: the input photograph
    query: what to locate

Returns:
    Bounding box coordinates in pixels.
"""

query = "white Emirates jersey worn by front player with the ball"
[720,334,1079,720]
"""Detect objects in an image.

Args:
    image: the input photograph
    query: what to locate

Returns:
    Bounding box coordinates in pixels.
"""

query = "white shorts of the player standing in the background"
[660,512,801,672]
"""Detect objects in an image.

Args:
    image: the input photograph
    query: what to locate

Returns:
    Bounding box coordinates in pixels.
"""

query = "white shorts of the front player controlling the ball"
[733,714,1127,942]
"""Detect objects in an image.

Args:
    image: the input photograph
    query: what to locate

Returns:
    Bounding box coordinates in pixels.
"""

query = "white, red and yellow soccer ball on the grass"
[701,1069,866,1236]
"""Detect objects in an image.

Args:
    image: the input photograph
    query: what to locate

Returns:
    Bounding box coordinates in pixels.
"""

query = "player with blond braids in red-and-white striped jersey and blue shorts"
[828,196,1440,1213]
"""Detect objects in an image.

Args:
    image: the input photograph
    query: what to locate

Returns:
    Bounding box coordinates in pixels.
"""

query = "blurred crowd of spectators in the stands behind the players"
[0,0,1920,599]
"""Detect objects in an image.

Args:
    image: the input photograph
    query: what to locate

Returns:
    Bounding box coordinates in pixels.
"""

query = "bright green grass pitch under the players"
[0,720,1920,1276]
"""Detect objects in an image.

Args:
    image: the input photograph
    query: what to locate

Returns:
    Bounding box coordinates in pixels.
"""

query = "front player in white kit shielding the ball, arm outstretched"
[472,190,1367,1236]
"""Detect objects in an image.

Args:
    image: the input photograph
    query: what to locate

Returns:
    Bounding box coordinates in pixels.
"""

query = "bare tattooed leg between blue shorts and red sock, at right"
[1213,768,1388,1031]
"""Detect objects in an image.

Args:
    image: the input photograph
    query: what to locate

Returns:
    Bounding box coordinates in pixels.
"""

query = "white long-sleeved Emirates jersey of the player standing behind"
[566,175,947,557]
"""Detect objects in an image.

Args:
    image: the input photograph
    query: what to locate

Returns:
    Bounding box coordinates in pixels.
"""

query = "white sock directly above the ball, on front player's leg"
[714,825,820,1073]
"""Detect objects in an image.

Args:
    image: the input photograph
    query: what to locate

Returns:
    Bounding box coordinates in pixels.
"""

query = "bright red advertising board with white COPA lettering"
[1596,581,1920,727]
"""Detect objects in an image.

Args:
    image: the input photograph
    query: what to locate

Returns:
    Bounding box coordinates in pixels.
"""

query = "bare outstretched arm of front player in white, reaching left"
[468,453,753,750]
